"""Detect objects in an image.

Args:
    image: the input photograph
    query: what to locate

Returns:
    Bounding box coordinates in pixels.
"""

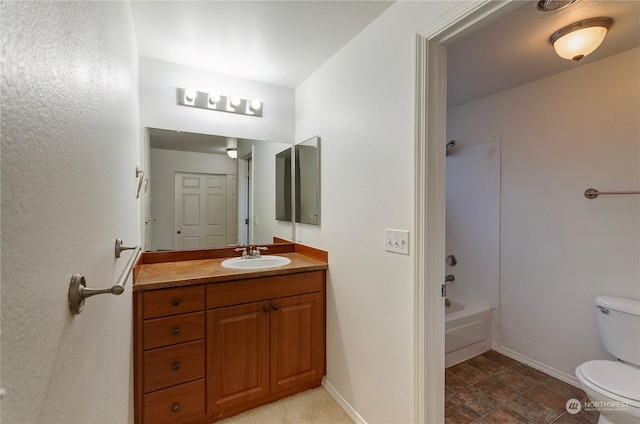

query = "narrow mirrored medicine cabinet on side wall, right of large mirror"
[294,136,320,225]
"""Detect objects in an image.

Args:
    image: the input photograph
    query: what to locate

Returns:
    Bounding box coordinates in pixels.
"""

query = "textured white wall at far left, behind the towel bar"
[1,2,140,424]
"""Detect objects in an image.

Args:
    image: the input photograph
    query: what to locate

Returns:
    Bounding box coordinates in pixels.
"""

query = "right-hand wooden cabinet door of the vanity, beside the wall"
[270,293,324,393]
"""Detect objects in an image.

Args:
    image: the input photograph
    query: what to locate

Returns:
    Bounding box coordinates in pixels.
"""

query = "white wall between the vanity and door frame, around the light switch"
[296,2,456,423]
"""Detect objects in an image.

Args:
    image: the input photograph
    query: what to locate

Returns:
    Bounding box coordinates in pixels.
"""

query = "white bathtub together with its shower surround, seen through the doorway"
[445,139,500,367]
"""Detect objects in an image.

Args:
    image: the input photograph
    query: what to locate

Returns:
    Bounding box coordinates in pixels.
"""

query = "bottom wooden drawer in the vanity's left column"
[144,380,206,424]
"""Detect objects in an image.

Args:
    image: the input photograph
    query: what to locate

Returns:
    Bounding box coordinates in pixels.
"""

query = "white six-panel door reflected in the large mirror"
[175,172,227,249]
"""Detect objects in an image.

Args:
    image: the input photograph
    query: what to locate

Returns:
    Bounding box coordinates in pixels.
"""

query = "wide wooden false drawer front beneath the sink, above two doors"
[207,271,324,309]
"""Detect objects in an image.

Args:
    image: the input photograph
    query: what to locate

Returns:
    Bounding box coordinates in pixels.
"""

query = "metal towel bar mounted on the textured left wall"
[69,239,142,315]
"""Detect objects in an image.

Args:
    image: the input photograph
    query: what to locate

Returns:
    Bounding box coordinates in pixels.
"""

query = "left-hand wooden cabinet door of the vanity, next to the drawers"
[207,301,270,417]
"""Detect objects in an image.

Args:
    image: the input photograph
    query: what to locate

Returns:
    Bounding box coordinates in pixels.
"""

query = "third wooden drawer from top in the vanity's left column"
[144,340,204,393]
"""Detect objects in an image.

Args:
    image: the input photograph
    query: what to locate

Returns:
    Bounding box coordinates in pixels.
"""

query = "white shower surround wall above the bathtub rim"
[446,139,500,309]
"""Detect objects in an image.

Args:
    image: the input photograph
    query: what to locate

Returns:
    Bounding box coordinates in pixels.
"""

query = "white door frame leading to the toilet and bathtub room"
[413,0,522,424]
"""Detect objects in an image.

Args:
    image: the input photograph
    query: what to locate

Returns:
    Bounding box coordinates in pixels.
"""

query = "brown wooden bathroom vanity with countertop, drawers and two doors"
[133,243,328,424]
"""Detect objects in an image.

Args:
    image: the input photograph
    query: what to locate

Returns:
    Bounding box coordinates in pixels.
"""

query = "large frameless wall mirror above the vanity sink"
[145,128,293,251]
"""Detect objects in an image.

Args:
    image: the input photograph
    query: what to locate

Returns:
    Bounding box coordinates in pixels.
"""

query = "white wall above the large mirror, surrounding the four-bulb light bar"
[139,57,294,143]
